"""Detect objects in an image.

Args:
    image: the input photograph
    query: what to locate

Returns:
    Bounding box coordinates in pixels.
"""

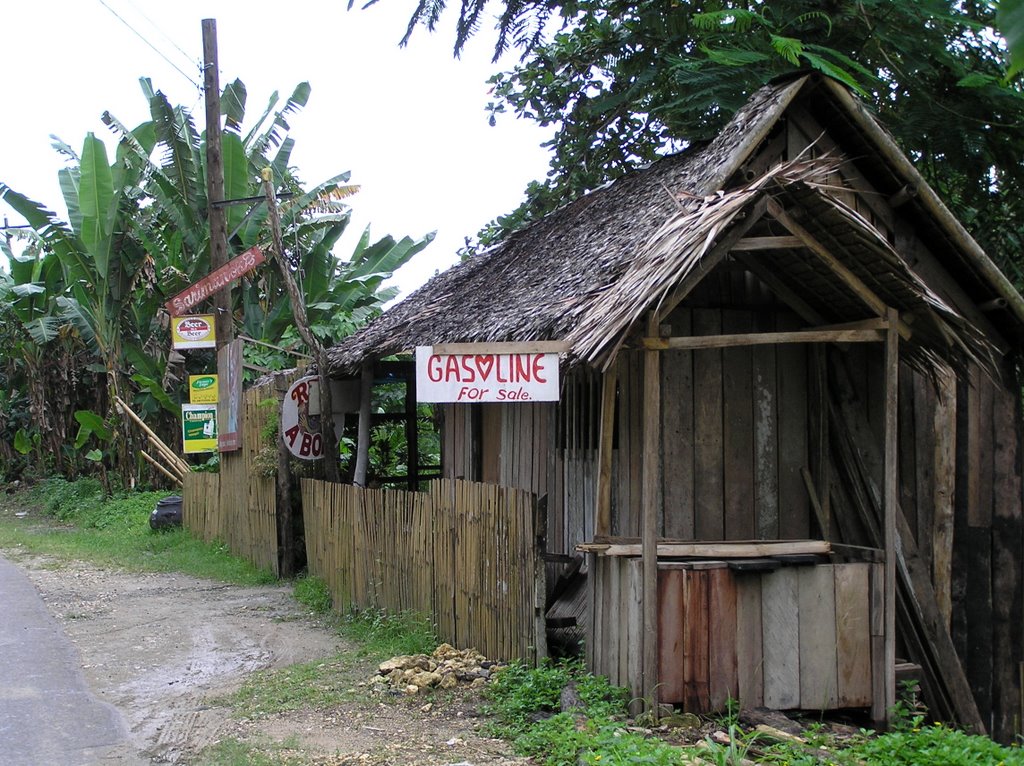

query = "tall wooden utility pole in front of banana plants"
[203,18,234,346]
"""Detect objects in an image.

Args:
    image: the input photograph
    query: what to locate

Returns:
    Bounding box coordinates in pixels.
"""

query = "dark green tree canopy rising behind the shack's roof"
[407,0,1024,278]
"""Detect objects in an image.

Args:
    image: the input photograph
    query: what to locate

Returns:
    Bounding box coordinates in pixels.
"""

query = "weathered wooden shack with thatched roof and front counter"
[331,76,1024,740]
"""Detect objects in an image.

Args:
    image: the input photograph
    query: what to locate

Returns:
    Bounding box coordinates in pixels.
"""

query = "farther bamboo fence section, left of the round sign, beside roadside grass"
[181,376,279,575]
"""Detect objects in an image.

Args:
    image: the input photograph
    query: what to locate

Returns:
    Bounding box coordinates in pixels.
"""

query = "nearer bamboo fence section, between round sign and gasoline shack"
[302,479,546,662]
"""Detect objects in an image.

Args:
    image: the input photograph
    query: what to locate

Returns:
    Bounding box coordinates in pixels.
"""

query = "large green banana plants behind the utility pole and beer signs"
[0,79,431,483]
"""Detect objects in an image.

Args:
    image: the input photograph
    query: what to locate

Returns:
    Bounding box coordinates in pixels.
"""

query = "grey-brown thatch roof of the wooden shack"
[330,77,1024,376]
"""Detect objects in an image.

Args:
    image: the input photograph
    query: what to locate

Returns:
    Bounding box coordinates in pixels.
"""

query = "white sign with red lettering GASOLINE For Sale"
[416,346,558,403]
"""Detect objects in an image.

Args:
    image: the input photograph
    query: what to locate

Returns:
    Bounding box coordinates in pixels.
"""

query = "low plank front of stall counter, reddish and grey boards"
[590,555,880,713]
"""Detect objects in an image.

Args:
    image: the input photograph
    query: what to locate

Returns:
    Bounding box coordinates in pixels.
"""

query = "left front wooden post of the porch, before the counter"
[641,312,662,720]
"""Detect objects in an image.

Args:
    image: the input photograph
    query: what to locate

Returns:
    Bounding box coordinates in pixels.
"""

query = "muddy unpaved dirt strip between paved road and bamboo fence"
[5,551,522,766]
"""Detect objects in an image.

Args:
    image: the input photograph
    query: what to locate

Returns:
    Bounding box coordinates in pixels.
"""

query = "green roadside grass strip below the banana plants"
[0,478,274,585]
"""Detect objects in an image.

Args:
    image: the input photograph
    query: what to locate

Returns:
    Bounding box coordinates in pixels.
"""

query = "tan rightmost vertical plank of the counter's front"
[835,563,871,708]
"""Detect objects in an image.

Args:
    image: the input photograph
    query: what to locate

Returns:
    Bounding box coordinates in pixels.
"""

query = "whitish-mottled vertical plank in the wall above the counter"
[752,312,779,540]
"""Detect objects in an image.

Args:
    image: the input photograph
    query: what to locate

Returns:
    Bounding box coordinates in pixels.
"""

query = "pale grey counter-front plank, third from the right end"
[761,567,800,710]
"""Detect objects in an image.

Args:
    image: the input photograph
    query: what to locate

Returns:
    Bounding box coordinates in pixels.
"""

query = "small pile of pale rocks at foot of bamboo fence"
[369,644,500,694]
